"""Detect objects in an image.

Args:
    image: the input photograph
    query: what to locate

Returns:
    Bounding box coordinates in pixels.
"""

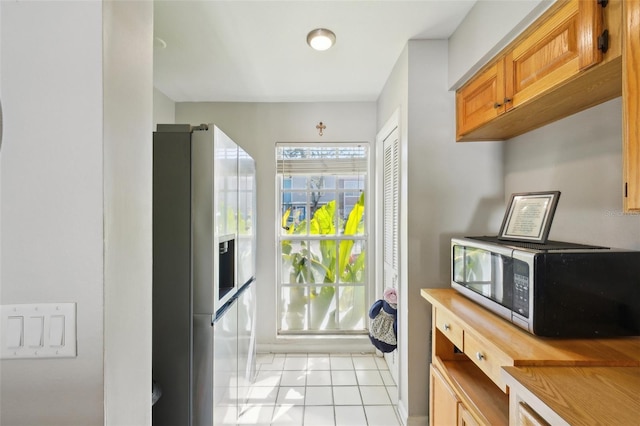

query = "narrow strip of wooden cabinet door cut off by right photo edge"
[622,1,640,212]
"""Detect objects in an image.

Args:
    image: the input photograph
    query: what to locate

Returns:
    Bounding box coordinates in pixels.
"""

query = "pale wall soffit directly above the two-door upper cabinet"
[448,0,555,89]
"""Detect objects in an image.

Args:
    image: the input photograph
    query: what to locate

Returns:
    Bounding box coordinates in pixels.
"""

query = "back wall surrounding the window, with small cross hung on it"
[176,102,376,353]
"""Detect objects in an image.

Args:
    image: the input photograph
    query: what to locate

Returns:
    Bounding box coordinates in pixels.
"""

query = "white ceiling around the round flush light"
[154,0,476,102]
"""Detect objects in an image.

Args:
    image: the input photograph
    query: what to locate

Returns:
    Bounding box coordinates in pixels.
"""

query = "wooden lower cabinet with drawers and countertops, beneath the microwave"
[421,289,640,426]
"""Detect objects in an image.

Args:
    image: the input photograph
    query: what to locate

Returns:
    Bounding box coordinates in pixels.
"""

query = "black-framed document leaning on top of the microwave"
[498,191,560,244]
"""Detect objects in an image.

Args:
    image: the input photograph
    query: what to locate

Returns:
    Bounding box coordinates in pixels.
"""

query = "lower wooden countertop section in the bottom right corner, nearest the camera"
[503,367,640,426]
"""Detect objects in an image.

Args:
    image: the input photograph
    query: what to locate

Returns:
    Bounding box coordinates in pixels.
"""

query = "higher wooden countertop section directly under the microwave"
[421,289,640,367]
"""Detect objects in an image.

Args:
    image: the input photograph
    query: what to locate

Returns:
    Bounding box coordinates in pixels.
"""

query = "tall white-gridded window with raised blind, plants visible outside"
[276,143,369,334]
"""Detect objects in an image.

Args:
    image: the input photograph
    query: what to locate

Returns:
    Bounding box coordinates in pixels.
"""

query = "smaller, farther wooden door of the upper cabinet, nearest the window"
[456,59,505,139]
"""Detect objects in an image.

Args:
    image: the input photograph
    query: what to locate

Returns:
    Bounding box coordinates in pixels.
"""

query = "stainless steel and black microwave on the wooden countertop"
[451,237,640,337]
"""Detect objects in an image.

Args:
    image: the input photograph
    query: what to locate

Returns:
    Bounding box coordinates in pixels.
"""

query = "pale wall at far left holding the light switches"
[0,1,152,426]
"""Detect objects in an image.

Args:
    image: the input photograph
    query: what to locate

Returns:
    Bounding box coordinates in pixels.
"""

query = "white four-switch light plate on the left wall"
[0,303,77,359]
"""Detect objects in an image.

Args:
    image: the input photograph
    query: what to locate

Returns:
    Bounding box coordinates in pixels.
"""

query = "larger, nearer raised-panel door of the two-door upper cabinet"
[505,0,603,110]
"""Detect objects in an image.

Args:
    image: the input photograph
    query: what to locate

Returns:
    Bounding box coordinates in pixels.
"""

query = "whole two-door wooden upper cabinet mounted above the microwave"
[456,0,622,141]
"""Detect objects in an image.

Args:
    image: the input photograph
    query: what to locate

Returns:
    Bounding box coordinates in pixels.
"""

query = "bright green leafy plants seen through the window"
[280,192,366,332]
